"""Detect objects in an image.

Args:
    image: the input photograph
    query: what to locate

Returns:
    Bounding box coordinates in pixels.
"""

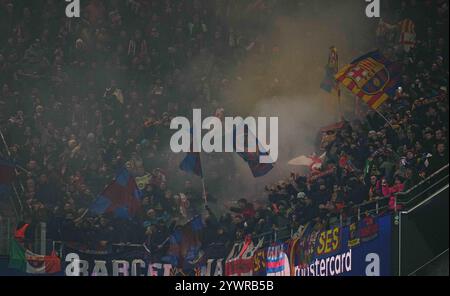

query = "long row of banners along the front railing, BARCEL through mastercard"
[0,215,392,276]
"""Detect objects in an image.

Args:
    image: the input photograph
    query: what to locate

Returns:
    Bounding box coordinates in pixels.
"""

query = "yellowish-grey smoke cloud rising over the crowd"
[172,0,377,207]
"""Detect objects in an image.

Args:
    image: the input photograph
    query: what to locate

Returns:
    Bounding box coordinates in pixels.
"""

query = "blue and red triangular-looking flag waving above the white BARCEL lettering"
[89,168,141,219]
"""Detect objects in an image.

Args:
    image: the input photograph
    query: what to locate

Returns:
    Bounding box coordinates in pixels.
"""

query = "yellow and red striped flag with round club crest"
[335,50,401,110]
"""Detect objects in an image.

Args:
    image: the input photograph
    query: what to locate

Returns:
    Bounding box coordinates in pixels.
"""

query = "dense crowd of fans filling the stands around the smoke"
[0,0,449,260]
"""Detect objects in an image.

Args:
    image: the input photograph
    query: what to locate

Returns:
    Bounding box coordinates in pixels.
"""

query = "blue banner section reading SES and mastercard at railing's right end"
[289,215,391,276]
